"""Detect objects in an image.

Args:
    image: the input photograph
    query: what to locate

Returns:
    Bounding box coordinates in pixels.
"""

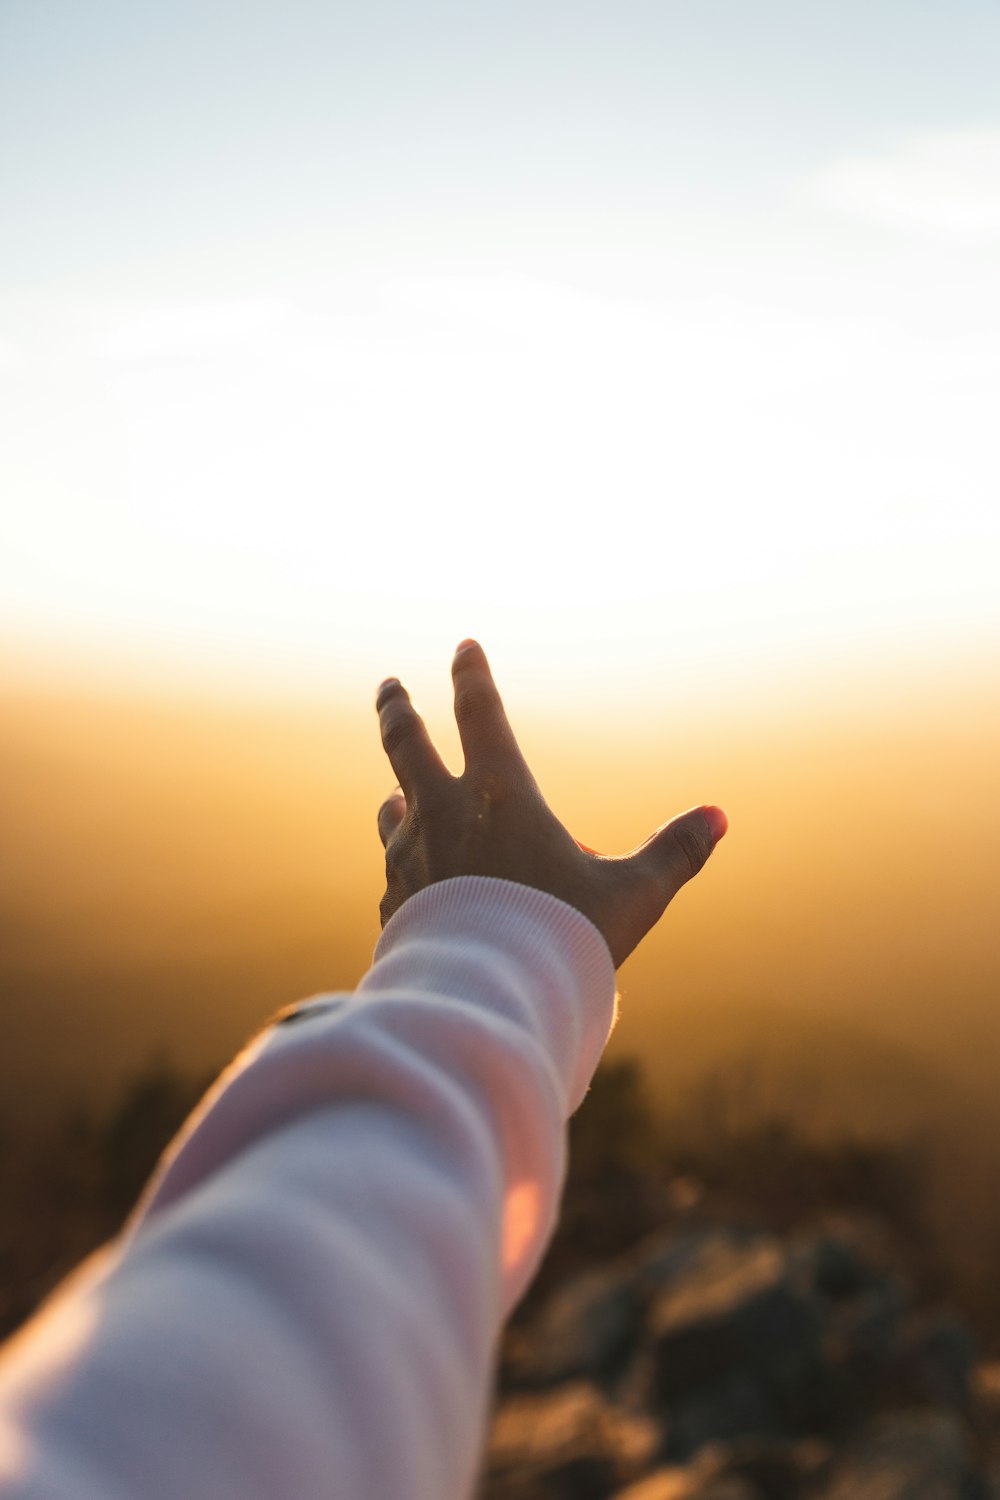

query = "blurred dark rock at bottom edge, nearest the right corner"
[816,1412,988,1500]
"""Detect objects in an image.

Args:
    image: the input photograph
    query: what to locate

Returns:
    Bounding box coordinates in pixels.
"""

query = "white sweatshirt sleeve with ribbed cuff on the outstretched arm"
[0,878,615,1500]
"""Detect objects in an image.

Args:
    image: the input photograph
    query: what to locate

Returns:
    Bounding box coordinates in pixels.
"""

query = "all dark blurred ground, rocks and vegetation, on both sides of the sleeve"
[0,1061,1000,1500]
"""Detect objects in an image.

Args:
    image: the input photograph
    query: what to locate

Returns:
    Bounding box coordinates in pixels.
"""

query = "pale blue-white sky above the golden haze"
[0,0,1000,692]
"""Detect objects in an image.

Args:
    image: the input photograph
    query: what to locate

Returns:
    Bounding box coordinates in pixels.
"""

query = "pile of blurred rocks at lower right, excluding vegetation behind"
[481,1215,1000,1500]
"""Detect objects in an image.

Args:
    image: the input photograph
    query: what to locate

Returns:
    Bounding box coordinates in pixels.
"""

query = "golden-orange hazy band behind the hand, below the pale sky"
[0,636,1000,1146]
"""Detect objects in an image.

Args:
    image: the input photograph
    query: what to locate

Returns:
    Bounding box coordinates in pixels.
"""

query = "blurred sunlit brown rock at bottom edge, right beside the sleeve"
[481,1380,660,1500]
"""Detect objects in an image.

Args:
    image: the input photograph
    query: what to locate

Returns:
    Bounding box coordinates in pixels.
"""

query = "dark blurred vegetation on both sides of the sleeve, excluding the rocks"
[0,1058,1000,1355]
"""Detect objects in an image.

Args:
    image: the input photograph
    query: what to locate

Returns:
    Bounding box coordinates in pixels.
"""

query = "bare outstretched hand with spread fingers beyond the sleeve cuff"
[375,641,729,968]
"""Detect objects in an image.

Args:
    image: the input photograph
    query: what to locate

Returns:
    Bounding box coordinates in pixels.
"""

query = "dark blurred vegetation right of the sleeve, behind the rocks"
[516,1059,1000,1356]
